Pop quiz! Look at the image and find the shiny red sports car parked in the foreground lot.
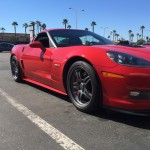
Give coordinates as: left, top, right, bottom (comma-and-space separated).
10, 29, 150, 113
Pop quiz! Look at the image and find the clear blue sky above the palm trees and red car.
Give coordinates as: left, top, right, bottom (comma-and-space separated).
0, 0, 150, 40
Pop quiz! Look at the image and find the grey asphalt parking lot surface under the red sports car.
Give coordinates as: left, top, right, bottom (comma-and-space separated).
0, 53, 150, 150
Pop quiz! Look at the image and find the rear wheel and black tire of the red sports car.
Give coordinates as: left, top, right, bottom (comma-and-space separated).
10, 55, 22, 82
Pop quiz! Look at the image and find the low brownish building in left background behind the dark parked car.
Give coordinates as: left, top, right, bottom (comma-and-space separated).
0, 32, 30, 44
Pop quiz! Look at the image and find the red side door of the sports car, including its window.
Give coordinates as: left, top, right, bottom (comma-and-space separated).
22, 33, 53, 85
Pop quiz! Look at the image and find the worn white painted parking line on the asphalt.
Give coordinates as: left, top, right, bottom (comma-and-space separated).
0, 88, 84, 150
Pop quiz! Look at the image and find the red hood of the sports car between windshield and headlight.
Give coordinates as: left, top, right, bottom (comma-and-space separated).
93, 45, 150, 61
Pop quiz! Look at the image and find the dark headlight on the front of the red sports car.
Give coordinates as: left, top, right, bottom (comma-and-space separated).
107, 51, 150, 67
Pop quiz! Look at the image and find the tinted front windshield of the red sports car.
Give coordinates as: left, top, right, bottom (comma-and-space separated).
49, 29, 114, 47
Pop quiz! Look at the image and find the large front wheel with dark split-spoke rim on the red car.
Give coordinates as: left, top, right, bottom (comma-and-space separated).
67, 61, 101, 112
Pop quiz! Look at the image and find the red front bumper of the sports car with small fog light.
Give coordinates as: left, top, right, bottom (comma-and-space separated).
97, 65, 150, 111
